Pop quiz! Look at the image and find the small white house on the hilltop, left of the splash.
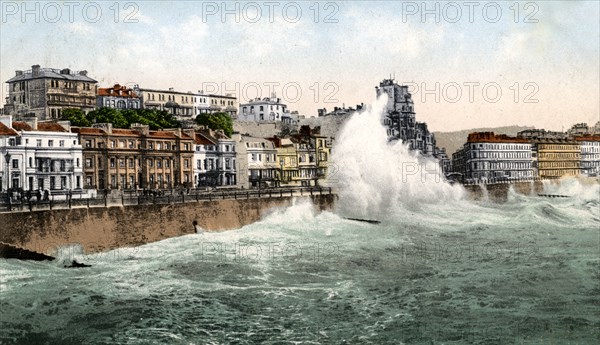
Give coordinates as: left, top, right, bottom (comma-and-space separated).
238, 97, 297, 122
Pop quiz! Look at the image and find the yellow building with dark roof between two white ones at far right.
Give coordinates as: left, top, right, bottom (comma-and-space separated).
534, 139, 581, 179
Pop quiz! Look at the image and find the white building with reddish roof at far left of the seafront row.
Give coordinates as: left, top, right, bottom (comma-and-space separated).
0, 116, 83, 194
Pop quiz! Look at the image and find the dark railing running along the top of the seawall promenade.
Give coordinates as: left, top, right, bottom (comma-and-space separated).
0, 187, 335, 213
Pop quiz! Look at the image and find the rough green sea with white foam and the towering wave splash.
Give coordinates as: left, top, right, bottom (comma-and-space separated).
0, 98, 600, 345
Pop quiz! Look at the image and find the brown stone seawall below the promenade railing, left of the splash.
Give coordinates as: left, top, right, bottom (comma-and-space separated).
0, 194, 337, 255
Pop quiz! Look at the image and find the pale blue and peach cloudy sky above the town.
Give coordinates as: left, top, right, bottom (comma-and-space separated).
0, 1, 600, 131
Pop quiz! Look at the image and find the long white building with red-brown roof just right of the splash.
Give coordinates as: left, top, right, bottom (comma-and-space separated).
452, 132, 535, 184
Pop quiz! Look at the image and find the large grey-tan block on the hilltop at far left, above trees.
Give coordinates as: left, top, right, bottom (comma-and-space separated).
4, 65, 97, 120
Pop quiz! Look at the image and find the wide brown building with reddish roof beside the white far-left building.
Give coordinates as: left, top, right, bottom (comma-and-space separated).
73, 124, 194, 190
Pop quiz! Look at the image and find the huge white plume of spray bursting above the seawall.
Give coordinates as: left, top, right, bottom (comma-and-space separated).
330, 94, 464, 218
